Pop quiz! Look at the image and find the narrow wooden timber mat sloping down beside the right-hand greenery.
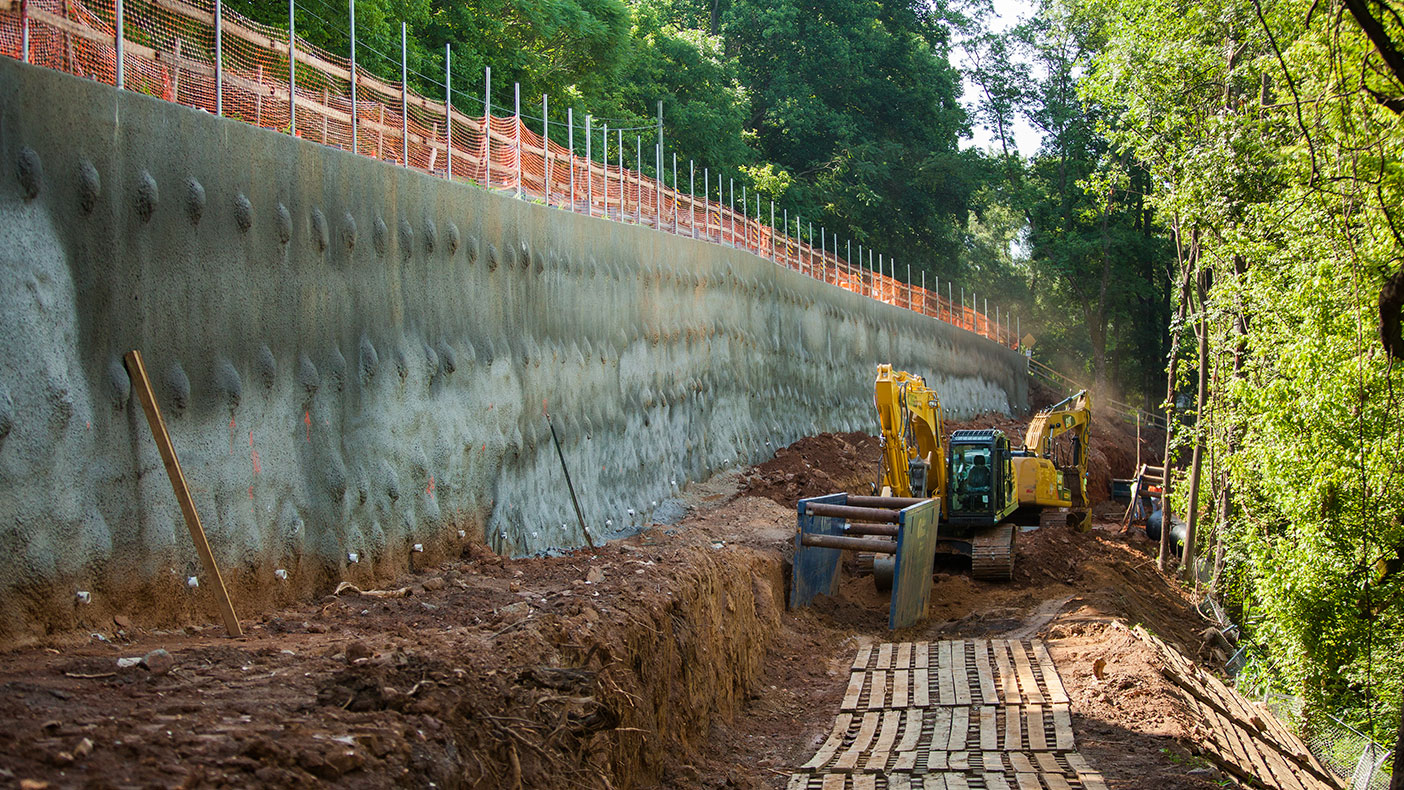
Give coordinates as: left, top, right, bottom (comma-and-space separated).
1132, 626, 1341, 790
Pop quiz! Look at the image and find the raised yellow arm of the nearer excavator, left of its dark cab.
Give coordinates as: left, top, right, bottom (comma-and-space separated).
873, 365, 946, 498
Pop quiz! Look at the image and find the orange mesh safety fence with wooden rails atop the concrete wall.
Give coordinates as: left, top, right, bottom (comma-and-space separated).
0, 0, 1019, 348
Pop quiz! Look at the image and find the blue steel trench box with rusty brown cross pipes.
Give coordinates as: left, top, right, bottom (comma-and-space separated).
789, 493, 941, 630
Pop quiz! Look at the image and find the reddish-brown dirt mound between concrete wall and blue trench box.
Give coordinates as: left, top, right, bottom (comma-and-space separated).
741, 432, 880, 508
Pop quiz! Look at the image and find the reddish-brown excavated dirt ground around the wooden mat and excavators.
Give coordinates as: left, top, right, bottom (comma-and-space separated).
0, 401, 1252, 790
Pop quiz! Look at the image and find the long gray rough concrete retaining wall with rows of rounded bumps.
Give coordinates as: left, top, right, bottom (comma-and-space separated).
0, 59, 1026, 637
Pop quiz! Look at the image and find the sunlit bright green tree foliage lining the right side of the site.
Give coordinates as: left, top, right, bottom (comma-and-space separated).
1071, 0, 1404, 742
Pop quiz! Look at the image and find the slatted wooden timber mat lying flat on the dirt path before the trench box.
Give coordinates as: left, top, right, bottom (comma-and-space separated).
789, 640, 1106, 790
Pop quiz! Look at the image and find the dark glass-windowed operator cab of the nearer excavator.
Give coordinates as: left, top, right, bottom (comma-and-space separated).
946, 429, 1018, 532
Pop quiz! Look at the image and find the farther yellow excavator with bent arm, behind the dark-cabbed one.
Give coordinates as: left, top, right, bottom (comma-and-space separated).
1014, 390, 1092, 532
